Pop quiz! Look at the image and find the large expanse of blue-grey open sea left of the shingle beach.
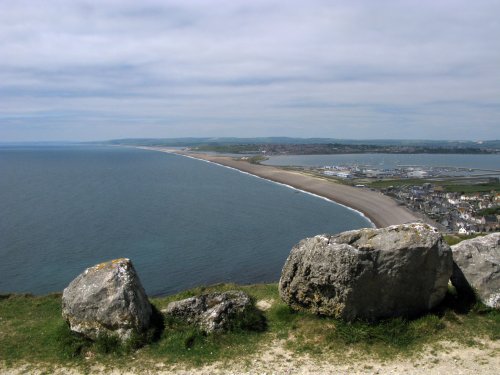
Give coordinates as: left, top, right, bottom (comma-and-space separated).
0, 146, 370, 295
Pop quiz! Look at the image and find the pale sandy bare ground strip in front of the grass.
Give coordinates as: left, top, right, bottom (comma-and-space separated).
0, 341, 500, 375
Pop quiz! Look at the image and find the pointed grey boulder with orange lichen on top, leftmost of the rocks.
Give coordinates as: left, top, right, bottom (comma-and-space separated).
62, 258, 152, 340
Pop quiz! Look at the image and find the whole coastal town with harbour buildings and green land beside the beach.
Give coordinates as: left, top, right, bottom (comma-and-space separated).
313, 166, 500, 235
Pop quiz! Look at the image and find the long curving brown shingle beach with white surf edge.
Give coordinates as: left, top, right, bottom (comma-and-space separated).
137, 147, 421, 228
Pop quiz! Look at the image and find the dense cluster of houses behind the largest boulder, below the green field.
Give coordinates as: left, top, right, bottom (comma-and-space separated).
382, 183, 500, 234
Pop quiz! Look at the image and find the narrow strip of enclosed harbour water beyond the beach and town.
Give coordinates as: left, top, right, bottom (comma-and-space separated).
264, 154, 500, 170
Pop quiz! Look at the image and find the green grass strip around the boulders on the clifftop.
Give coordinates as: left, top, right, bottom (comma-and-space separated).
0, 284, 500, 368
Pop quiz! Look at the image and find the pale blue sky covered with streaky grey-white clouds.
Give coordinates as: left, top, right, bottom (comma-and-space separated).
0, 0, 500, 142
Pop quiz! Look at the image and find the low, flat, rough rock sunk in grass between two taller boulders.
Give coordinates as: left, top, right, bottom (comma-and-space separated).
162, 291, 253, 333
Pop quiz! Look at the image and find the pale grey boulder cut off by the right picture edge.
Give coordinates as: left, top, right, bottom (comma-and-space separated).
451, 233, 500, 309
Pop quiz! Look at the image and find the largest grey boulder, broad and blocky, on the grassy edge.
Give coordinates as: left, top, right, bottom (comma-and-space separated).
279, 223, 452, 320
